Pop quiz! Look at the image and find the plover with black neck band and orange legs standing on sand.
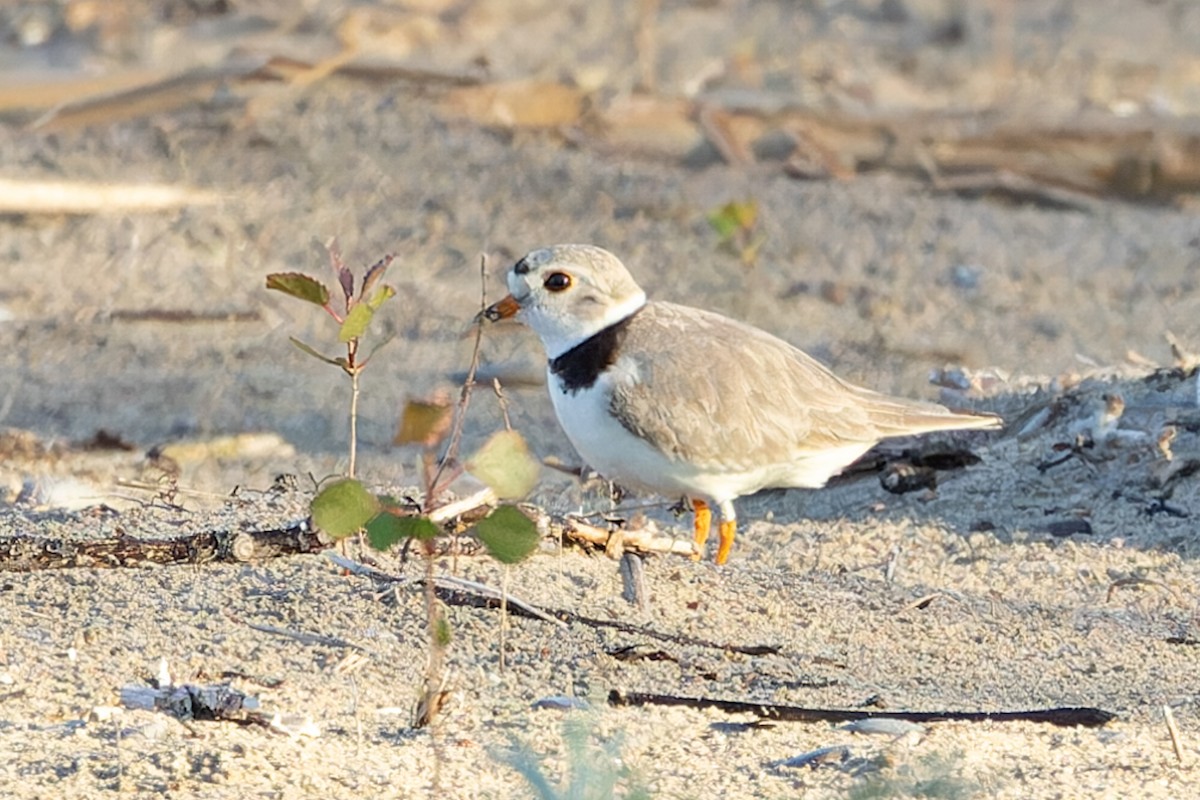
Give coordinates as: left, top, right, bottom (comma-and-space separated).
479, 245, 1002, 565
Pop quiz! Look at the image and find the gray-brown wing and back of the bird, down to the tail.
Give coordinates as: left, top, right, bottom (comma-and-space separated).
611, 302, 991, 469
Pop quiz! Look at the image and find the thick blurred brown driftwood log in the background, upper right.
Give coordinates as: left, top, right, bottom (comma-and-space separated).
588, 92, 1200, 203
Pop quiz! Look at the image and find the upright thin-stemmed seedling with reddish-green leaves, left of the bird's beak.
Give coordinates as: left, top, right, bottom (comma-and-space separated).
266, 242, 396, 477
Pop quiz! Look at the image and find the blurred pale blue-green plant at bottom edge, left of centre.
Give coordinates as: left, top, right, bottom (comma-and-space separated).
493, 716, 650, 800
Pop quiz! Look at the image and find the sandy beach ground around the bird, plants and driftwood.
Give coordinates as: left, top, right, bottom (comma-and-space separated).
0, 1, 1200, 799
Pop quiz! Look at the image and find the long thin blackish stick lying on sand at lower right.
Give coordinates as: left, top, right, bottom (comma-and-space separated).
608, 690, 1117, 728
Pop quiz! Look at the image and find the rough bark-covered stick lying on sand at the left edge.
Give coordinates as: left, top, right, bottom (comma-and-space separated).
0, 522, 331, 572
